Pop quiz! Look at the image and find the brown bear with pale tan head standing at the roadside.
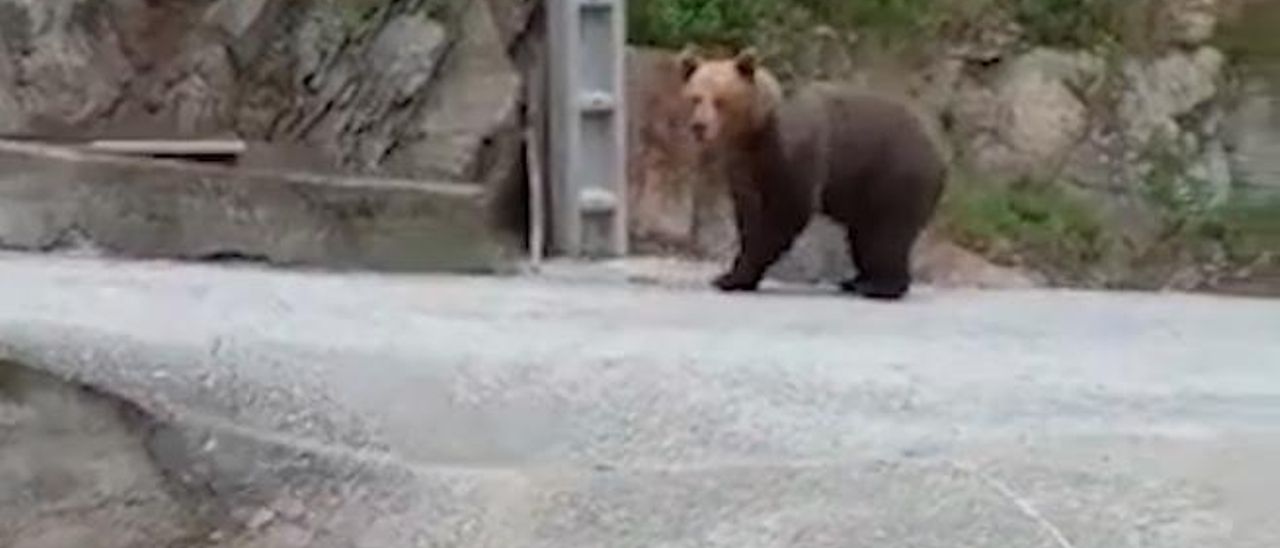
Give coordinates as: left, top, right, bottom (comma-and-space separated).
681, 49, 946, 300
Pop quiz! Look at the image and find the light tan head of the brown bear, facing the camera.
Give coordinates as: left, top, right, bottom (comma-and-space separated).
680, 47, 782, 145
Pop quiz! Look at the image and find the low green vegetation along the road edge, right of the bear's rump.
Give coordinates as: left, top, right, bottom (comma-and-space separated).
938, 154, 1280, 288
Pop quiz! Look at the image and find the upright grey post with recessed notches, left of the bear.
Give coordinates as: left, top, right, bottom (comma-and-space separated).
547, 0, 627, 256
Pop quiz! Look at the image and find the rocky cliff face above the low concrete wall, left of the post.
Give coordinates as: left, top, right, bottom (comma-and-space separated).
0, 0, 536, 186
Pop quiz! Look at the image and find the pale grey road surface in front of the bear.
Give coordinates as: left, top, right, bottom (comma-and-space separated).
0, 256, 1280, 548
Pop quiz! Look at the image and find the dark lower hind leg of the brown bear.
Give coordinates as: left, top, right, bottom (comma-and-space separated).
840, 222, 918, 300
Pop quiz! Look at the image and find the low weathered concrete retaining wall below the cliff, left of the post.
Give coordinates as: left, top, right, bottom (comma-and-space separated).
0, 143, 518, 271
